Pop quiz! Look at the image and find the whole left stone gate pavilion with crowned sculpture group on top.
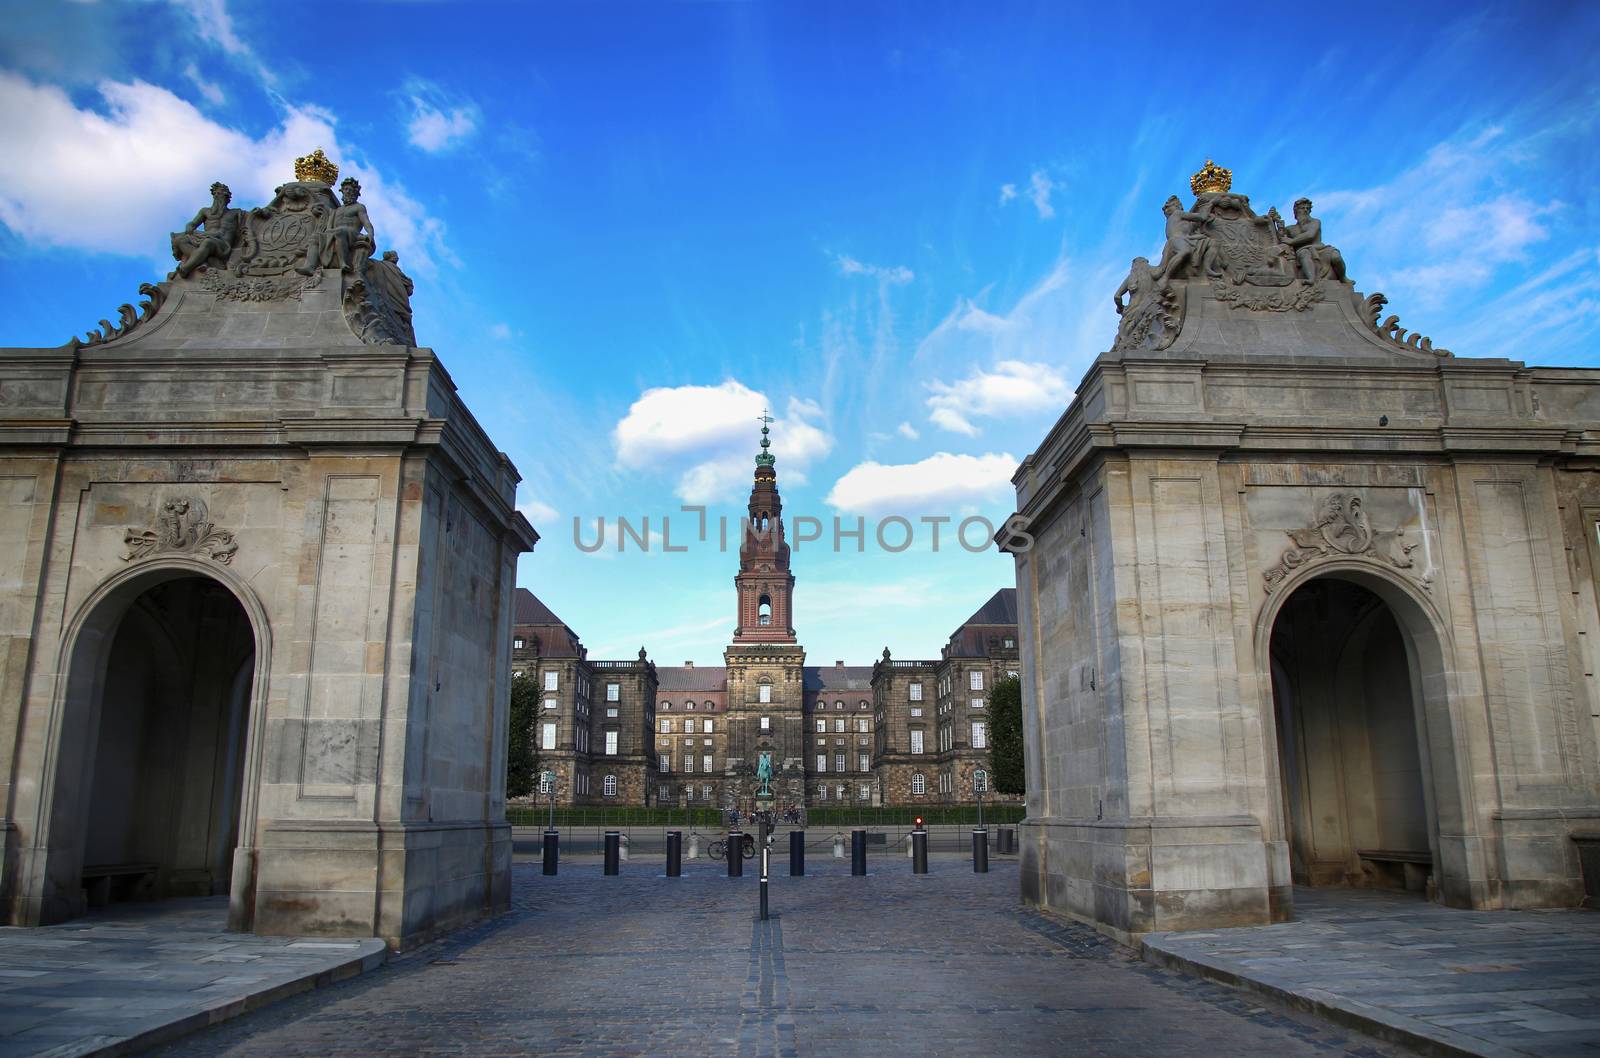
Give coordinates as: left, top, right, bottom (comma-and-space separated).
0, 150, 536, 946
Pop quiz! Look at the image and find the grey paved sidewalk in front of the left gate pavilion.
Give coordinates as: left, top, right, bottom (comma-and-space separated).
0, 896, 386, 1058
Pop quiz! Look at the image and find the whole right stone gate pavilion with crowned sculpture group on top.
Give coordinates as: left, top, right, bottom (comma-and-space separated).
1010, 162, 1600, 936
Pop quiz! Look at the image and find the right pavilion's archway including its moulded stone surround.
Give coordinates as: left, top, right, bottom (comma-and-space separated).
1258, 565, 1482, 906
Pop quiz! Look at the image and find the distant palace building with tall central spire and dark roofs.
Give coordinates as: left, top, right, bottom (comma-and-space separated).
512, 426, 1018, 808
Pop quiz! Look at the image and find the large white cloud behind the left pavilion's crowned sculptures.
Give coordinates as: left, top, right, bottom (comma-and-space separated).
0, 72, 454, 275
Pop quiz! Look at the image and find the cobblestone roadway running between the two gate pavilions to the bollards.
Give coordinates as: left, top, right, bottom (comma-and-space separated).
144, 856, 1403, 1058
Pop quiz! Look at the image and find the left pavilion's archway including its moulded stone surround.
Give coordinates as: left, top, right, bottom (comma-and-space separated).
34, 562, 266, 928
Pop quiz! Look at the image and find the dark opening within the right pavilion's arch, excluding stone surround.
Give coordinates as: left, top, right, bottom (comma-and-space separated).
1270, 576, 1437, 895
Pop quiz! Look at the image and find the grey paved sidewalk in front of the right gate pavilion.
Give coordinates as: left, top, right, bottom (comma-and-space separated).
1142, 888, 1600, 1058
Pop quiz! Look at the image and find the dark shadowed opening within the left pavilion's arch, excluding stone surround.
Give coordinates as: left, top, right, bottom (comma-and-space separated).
78, 576, 254, 906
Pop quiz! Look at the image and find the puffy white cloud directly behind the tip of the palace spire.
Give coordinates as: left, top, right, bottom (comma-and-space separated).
611, 379, 834, 503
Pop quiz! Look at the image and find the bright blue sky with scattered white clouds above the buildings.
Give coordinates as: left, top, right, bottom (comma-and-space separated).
0, 0, 1600, 663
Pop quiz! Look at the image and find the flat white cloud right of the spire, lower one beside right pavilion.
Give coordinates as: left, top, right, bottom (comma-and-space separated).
826, 451, 1018, 514
